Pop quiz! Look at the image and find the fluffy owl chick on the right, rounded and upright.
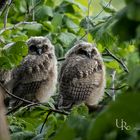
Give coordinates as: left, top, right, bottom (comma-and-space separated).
58, 42, 106, 109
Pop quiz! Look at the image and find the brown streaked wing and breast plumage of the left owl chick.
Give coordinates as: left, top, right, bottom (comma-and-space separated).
7, 55, 51, 94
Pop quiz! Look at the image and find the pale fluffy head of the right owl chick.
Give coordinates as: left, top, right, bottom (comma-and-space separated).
66, 42, 100, 59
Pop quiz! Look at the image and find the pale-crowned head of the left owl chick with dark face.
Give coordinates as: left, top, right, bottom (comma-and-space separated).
27, 36, 54, 55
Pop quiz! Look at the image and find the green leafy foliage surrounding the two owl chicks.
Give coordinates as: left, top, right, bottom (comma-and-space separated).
0, 0, 140, 140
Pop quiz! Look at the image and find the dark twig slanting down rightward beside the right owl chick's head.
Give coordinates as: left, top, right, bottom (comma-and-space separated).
102, 48, 129, 73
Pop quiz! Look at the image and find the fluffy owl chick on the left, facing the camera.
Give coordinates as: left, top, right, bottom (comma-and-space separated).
8, 37, 57, 102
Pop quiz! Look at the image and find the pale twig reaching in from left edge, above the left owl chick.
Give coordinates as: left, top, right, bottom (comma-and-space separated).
0, 21, 37, 34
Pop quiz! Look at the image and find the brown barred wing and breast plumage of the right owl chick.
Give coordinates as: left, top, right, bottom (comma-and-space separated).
59, 56, 102, 109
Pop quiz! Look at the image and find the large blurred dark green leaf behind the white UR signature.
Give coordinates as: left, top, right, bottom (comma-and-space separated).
87, 93, 140, 140
